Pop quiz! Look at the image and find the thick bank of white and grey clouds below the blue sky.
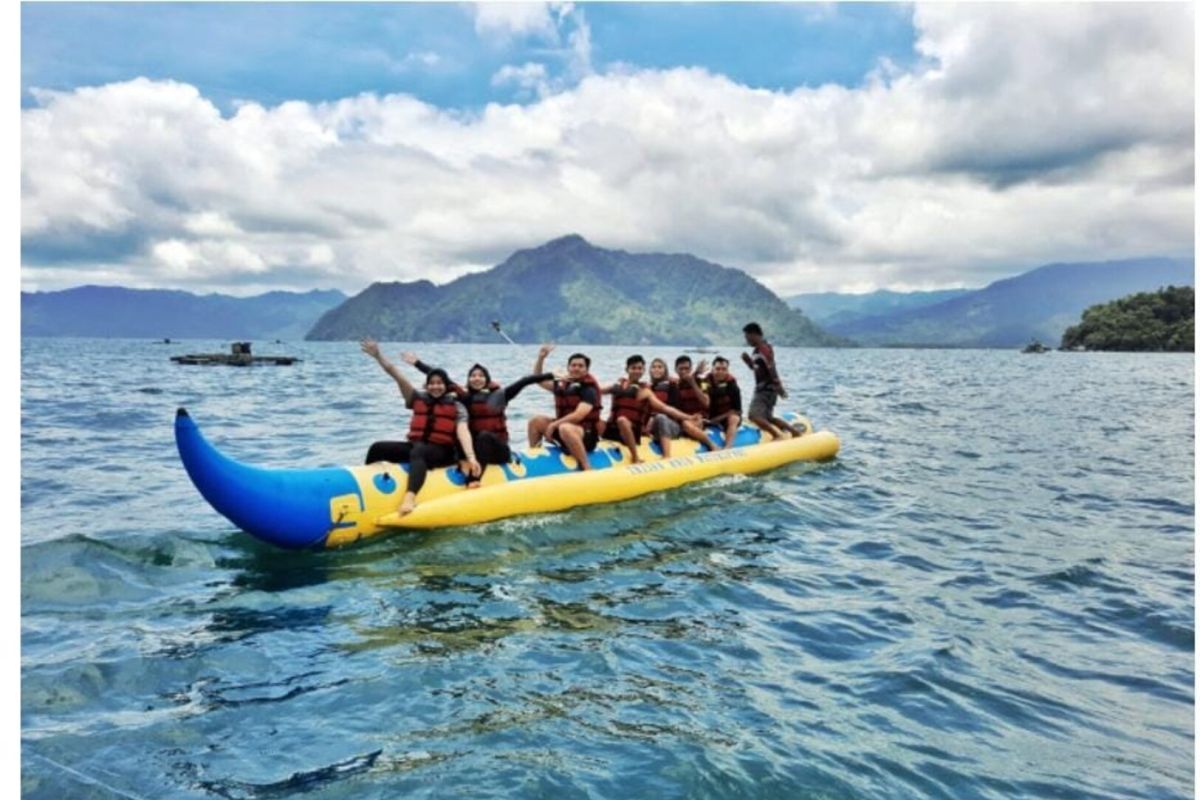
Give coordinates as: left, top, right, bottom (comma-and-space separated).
22, 4, 1194, 294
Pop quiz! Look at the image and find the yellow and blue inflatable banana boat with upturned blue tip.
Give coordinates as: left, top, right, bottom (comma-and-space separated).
175, 408, 840, 548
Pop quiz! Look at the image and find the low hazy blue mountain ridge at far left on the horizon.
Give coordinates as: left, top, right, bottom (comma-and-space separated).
20, 285, 346, 339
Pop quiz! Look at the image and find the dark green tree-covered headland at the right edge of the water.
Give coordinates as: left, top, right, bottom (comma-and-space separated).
1062, 285, 1195, 353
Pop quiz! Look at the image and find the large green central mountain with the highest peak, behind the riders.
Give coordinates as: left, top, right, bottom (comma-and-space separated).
307, 235, 846, 345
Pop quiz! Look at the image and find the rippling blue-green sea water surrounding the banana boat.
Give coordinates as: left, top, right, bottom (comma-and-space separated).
20, 339, 1195, 800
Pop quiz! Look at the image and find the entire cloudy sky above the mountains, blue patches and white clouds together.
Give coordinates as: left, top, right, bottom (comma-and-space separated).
20, 2, 1195, 295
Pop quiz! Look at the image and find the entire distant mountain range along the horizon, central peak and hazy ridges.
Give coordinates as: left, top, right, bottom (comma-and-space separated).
20, 245, 1195, 347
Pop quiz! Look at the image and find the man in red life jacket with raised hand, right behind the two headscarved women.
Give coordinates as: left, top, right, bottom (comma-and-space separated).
529, 344, 601, 470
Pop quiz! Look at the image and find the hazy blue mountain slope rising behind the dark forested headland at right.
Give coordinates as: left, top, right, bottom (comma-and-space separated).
829, 258, 1195, 347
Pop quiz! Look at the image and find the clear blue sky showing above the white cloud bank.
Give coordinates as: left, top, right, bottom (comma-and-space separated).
20, 2, 914, 110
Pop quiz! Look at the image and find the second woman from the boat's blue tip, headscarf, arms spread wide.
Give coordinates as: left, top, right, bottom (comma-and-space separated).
401, 353, 554, 489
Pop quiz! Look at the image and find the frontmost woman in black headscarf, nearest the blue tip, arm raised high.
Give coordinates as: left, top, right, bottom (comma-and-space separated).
361, 339, 481, 516
